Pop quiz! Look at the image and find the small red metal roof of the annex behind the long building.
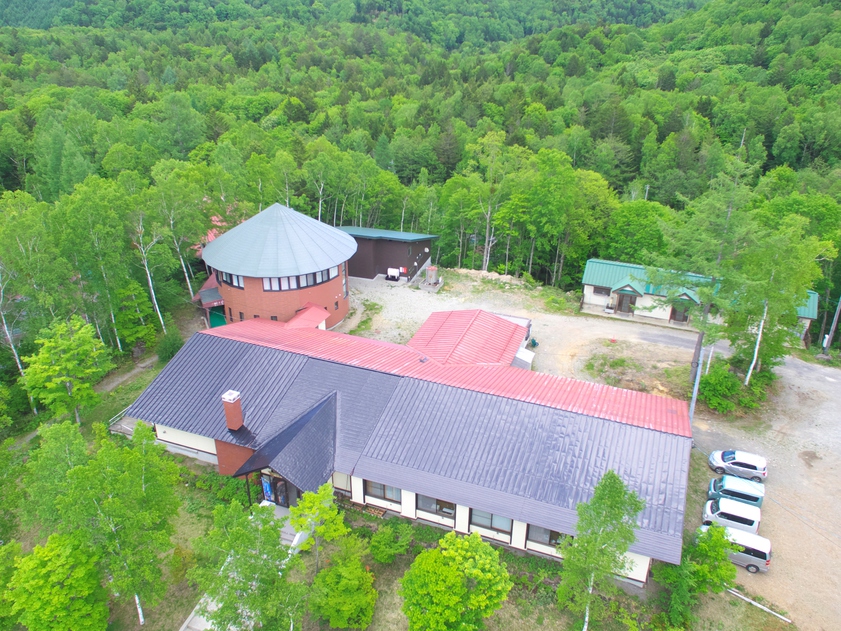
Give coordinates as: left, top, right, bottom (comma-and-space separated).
407, 309, 528, 366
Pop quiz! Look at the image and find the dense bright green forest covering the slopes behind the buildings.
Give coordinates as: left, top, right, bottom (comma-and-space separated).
0, 0, 841, 428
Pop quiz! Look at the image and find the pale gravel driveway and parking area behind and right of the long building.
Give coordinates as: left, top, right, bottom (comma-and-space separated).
337, 271, 841, 631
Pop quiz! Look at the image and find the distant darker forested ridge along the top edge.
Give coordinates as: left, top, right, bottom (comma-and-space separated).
0, 0, 705, 37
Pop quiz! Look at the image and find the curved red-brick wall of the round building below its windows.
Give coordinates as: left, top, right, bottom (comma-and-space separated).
219, 267, 348, 329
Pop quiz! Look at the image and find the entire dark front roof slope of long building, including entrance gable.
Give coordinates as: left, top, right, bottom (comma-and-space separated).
127, 334, 692, 563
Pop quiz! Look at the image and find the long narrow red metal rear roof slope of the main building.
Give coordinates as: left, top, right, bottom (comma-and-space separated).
202, 319, 692, 437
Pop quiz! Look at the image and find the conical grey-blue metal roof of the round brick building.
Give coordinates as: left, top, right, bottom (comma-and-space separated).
202, 204, 356, 278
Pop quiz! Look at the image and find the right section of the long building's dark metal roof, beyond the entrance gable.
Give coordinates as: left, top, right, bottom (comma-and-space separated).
353, 379, 692, 563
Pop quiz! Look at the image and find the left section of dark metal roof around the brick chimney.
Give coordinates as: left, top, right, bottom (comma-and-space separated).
126, 333, 400, 454
